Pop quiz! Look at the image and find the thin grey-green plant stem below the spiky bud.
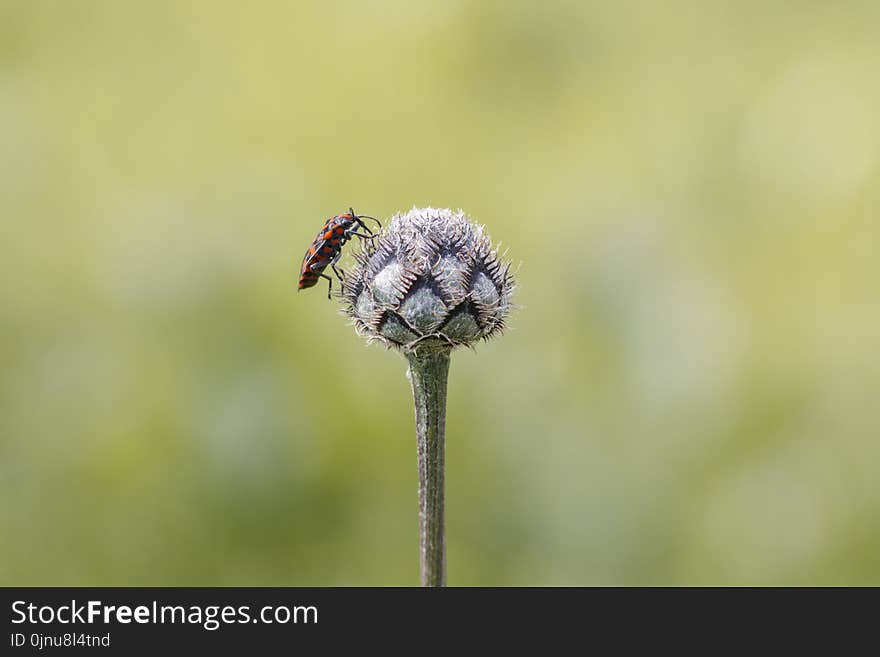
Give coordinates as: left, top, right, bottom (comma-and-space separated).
406, 348, 450, 586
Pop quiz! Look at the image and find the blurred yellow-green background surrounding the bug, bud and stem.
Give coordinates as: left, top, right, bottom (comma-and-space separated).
0, 0, 880, 585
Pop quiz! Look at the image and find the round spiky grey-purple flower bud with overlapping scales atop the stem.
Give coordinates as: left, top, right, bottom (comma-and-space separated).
342, 208, 513, 351
